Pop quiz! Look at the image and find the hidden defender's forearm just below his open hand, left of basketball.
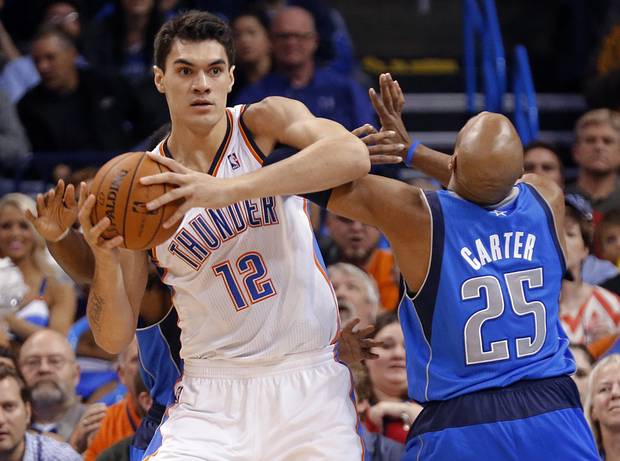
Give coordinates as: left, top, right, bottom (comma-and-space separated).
47, 229, 95, 284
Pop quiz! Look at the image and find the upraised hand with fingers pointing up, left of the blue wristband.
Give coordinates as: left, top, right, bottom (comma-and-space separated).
368, 74, 411, 159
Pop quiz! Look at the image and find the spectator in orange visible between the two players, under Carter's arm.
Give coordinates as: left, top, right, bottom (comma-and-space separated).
321, 213, 399, 310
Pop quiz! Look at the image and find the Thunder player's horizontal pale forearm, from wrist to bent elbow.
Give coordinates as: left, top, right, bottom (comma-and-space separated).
231, 136, 370, 201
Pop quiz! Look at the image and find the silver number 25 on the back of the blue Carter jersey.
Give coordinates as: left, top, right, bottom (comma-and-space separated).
461, 267, 547, 365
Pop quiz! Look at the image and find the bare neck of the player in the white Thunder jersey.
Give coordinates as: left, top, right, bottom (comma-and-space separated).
167, 115, 228, 173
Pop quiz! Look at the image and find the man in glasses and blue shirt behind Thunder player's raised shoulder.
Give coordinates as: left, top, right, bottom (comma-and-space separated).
237, 7, 374, 130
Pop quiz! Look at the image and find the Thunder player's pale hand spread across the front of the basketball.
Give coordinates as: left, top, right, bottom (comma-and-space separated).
140, 153, 230, 227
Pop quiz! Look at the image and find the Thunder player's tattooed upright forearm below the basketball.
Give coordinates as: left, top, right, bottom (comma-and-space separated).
86, 262, 137, 354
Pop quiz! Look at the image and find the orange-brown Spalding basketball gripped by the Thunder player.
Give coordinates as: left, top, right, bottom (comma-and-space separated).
91, 152, 181, 250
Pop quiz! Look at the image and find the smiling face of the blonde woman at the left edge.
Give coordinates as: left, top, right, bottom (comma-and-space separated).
0, 205, 34, 262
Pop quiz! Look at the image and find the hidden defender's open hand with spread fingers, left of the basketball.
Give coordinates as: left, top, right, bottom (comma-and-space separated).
26, 179, 78, 242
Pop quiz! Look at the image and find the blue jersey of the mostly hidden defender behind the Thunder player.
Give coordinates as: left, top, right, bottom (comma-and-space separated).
136, 307, 183, 407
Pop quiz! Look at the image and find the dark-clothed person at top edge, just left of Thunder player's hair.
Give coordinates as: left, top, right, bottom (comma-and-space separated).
84, 0, 162, 80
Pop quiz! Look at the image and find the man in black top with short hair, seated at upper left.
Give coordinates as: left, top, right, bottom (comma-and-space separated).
17, 28, 142, 151
